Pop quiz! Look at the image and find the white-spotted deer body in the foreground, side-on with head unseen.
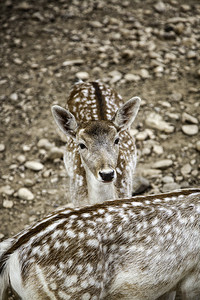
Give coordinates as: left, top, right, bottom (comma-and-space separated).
0, 188, 200, 300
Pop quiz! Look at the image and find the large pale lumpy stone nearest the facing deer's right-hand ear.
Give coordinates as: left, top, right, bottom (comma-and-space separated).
146, 113, 174, 133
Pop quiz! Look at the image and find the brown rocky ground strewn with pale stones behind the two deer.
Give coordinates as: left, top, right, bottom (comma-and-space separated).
0, 0, 200, 260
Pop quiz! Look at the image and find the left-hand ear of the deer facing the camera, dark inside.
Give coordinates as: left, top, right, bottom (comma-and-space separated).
51, 105, 78, 138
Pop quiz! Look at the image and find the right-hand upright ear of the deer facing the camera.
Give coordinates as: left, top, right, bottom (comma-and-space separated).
112, 97, 141, 131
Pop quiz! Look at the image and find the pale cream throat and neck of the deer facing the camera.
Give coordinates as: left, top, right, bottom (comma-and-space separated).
86, 170, 117, 205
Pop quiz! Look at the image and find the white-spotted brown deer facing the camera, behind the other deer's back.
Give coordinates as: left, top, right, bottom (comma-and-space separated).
52, 81, 140, 206
